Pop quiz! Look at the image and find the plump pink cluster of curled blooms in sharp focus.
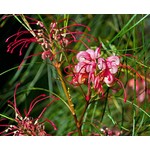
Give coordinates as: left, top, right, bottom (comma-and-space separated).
72, 48, 120, 99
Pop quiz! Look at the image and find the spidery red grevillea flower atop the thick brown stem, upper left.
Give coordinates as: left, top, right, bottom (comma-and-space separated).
6, 16, 94, 63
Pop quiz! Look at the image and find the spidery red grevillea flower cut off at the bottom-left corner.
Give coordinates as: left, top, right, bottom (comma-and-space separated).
0, 84, 58, 136
